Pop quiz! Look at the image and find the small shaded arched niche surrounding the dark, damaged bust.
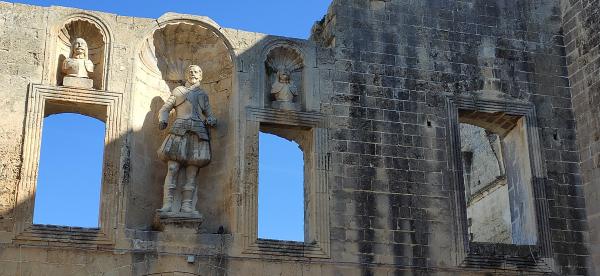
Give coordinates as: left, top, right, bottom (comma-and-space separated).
264, 45, 306, 110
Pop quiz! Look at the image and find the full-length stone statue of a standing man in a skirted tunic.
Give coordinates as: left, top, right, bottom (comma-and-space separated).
158, 65, 217, 216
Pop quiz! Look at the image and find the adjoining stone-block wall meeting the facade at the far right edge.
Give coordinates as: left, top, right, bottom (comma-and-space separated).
560, 1, 600, 273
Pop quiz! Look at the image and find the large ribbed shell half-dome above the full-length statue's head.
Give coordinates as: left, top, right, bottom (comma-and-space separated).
140, 22, 233, 85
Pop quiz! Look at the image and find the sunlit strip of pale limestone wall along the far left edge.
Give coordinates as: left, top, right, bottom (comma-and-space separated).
0, 3, 46, 233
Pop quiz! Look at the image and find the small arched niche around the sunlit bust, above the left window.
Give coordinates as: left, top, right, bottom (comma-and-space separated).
52, 15, 110, 90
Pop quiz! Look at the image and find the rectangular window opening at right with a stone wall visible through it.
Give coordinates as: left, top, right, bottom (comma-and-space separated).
459, 110, 537, 245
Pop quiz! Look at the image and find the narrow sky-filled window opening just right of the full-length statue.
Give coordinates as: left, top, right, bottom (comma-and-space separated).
258, 132, 304, 242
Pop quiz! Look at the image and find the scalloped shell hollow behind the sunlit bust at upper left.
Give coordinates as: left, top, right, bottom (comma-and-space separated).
56, 18, 106, 89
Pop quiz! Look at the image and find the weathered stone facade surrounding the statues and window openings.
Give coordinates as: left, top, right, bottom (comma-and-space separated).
0, 0, 600, 276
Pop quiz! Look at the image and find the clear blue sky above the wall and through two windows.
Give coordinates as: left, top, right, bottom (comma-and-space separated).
18, 0, 331, 241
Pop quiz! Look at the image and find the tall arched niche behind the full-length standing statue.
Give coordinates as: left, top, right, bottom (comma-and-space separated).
131, 18, 237, 231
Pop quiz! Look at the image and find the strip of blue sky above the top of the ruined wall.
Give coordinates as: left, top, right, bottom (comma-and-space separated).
9, 0, 331, 38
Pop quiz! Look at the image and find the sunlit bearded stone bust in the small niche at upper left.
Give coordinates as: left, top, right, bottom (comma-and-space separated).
62, 37, 94, 88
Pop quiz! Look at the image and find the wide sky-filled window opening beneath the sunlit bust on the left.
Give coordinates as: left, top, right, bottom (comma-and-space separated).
33, 113, 105, 228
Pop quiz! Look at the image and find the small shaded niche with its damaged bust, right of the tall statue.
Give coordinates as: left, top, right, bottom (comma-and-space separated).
265, 46, 305, 111
